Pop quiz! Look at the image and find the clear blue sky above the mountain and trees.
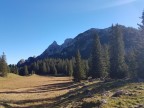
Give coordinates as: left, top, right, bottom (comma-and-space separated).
0, 0, 144, 64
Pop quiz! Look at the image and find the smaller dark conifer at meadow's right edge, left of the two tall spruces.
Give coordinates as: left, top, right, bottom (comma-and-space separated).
74, 50, 86, 82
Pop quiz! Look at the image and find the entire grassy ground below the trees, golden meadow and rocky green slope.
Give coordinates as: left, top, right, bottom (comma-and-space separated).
0, 74, 144, 108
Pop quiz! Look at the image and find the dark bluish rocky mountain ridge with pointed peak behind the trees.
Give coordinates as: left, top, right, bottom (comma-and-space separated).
18, 25, 144, 65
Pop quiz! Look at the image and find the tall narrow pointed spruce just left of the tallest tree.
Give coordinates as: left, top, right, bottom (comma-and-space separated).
90, 34, 104, 78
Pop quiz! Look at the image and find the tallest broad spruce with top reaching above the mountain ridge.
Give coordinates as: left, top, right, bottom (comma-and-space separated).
110, 24, 128, 79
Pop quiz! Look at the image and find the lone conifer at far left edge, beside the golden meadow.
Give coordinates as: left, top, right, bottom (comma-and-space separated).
0, 53, 8, 77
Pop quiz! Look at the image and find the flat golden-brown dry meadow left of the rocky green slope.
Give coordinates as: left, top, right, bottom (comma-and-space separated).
0, 74, 72, 108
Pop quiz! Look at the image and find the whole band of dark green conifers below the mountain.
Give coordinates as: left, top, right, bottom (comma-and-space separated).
0, 12, 144, 81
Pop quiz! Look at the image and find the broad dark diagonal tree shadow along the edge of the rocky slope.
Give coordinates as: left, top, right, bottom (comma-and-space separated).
49, 80, 136, 108
